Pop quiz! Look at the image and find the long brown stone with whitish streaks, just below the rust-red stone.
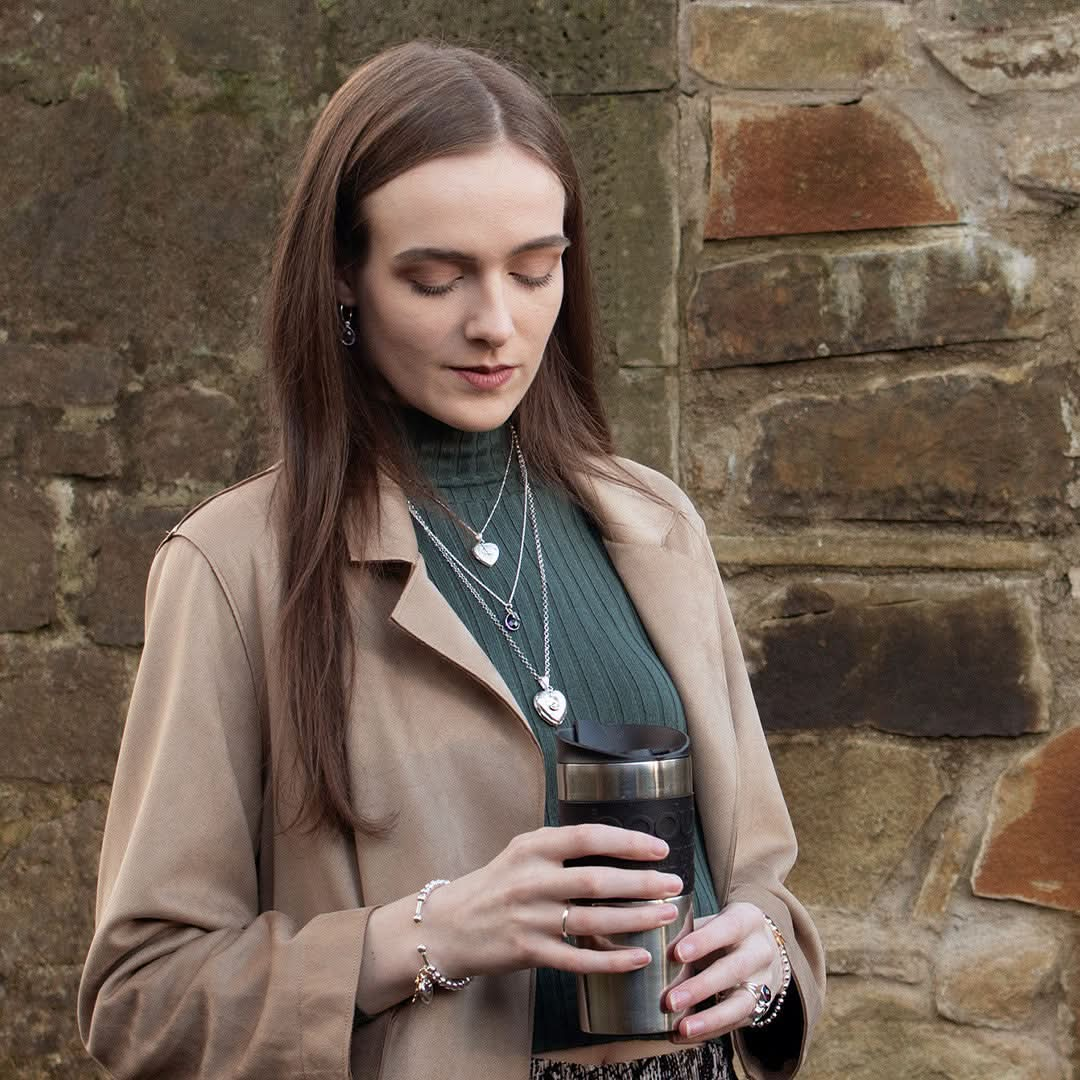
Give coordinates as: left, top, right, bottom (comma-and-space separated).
687, 233, 1040, 368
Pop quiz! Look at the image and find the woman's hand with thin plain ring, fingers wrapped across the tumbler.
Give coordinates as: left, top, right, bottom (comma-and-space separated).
414, 824, 683, 978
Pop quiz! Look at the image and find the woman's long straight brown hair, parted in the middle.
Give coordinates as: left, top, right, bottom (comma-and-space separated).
266, 41, 639, 831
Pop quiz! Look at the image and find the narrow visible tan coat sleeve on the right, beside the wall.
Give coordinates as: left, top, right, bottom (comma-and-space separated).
691, 511, 825, 1080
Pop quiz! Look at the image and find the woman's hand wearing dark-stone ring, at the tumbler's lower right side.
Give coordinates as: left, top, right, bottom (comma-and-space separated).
665, 903, 784, 1041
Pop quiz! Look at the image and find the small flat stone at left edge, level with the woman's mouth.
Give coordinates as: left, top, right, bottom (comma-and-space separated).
0, 345, 124, 408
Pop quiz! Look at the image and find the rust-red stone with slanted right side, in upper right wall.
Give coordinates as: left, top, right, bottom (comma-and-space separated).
705, 98, 959, 240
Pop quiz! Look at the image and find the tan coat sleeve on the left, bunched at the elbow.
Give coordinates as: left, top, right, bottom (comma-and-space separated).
78, 536, 370, 1080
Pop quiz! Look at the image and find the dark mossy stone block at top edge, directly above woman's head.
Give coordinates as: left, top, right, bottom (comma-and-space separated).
328, 0, 676, 94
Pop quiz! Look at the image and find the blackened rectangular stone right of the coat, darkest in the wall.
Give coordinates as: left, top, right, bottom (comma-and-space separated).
741, 580, 1051, 737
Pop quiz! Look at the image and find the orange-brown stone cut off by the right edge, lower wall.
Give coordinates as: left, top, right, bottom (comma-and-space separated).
972, 727, 1080, 912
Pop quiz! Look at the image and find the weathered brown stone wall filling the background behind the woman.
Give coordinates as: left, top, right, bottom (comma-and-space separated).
0, 0, 1080, 1080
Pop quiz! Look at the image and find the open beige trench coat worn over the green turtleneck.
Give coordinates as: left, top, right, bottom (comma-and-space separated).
78, 462, 824, 1080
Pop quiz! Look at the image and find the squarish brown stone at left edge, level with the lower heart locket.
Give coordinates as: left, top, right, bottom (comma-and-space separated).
0, 638, 129, 783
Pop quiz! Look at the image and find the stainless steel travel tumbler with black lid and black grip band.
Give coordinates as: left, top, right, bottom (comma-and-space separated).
556, 725, 694, 1036
